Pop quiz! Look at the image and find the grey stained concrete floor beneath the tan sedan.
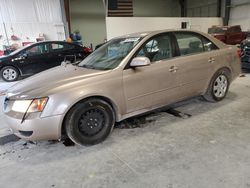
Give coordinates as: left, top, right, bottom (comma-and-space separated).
0, 74, 250, 188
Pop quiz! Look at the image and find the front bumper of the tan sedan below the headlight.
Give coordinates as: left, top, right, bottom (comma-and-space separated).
4, 114, 63, 140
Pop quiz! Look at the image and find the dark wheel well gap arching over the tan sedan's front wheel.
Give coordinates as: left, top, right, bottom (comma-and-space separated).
61, 96, 118, 135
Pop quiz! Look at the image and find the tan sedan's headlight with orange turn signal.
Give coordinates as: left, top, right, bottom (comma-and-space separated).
12, 97, 48, 113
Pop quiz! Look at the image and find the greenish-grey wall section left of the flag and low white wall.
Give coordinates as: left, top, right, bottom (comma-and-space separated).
70, 0, 106, 46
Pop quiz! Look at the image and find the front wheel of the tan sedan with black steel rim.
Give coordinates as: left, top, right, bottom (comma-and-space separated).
64, 99, 115, 145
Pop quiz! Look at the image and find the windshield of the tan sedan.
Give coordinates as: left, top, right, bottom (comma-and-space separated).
78, 37, 142, 70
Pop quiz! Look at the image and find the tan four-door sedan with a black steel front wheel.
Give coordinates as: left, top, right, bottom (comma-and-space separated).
1, 30, 241, 145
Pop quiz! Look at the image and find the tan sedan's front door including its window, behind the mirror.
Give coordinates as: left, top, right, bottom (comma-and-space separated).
123, 34, 182, 113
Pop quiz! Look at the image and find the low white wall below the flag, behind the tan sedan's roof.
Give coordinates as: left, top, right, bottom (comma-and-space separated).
106, 17, 222, 39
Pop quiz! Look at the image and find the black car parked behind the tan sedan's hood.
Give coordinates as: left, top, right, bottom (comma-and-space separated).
0, 41, 91, 82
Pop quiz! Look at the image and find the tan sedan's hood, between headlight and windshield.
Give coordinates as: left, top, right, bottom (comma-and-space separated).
7, 64, 111, 99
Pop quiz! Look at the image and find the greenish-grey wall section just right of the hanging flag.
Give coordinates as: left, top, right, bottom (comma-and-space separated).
133, 0, 180, 17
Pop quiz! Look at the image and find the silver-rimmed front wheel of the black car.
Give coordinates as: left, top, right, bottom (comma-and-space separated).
1, 66, 20, 82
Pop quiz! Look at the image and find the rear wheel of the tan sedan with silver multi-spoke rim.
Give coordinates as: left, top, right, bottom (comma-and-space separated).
203, 69, 230, 102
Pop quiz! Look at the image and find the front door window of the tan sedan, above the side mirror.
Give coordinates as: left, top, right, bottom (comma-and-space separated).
136, 35, 172, 62
